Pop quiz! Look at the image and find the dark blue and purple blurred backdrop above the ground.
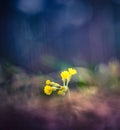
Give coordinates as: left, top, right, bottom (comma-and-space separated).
0, 0, 120, 72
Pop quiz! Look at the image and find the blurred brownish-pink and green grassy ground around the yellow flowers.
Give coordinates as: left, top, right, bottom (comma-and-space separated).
0, 61, 120, 130
